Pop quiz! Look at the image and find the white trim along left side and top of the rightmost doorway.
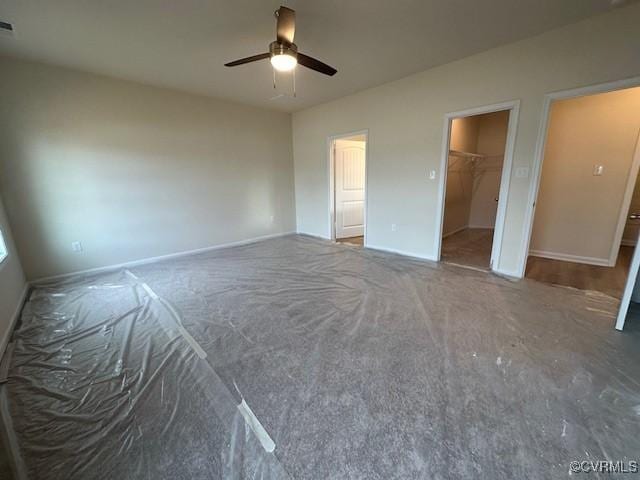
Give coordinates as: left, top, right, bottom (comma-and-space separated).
518, 77, 640, 278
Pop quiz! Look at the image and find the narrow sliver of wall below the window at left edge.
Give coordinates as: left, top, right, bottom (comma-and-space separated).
0, 193, 26, 358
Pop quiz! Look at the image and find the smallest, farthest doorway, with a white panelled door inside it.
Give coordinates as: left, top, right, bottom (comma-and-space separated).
329, 131, 368, 247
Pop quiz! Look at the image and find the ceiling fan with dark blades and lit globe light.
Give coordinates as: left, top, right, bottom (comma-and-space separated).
224, 7, 337, 76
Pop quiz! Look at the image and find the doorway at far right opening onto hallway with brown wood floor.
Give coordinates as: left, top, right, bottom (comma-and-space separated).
525, 87, 640, 299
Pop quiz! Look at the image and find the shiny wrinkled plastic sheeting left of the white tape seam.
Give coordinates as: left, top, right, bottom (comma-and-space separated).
7, 271, 288, 479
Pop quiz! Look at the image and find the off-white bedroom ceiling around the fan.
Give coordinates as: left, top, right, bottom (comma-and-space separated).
0, 0, 632, 111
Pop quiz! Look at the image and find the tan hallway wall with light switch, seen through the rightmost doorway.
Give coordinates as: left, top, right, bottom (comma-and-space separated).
531, 88, 640, 263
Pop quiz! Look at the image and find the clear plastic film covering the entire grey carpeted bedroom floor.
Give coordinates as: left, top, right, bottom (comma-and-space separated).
0, 235, 640, 480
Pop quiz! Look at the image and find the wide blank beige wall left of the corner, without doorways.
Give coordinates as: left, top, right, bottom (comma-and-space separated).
0, 58, 295, 279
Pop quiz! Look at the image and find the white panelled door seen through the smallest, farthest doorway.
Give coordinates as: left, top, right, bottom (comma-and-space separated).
334, 140, 366, 238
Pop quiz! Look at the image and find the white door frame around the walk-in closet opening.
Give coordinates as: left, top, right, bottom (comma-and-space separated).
434, 100, 520, 273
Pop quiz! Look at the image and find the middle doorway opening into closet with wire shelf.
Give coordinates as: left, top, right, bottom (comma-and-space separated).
437, 102, 518, 270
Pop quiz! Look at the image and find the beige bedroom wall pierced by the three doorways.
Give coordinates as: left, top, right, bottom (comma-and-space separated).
293, 4, 640, 275
